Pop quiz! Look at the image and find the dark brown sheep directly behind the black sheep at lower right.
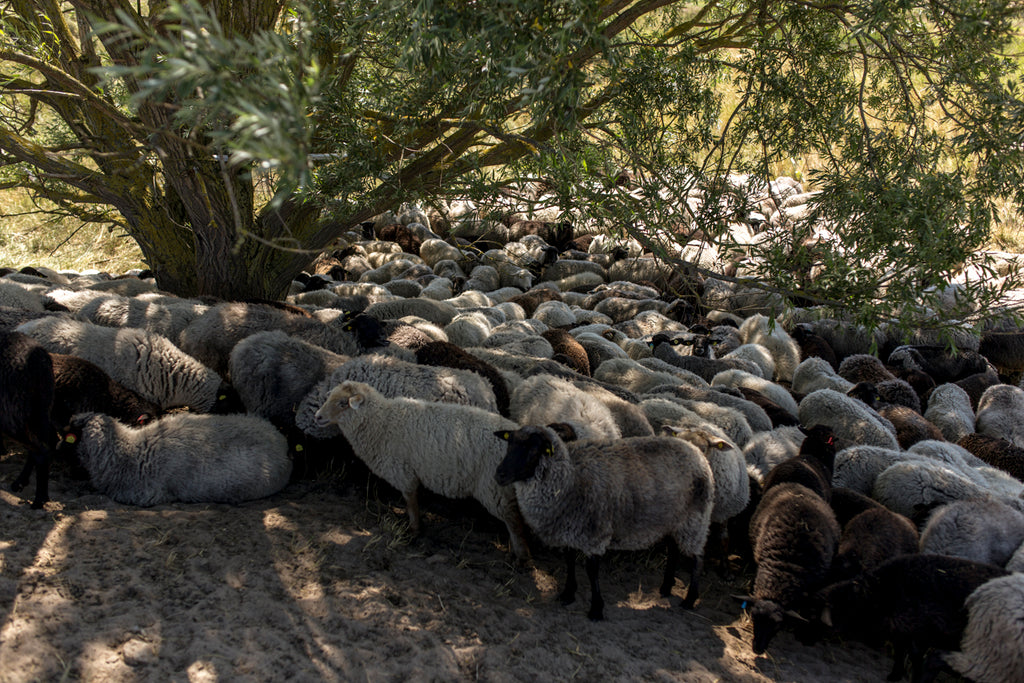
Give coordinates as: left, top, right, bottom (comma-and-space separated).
831, 507, 920, 582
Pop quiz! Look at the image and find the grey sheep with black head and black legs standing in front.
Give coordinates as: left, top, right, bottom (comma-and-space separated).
495, 425, 715, 621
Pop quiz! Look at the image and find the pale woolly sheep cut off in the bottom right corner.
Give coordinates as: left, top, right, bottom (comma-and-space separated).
945, 573, 1024, 683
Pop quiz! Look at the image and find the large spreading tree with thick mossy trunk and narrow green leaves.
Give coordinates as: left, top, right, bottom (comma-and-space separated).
0, 0, 1024, 331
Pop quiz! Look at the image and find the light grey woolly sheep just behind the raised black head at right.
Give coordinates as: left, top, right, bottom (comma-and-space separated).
797, 389, 899, 450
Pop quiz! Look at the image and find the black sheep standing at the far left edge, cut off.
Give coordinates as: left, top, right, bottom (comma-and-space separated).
0, 332, 57, 510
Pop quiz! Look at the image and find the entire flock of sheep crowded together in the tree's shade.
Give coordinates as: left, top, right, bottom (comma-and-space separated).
0, 178, 1024, 682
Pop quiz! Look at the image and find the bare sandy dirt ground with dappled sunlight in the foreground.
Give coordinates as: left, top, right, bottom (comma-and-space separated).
0, 452, 951, 683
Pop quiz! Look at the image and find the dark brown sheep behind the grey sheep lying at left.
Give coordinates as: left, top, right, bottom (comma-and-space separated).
50, 353, 160, 427
